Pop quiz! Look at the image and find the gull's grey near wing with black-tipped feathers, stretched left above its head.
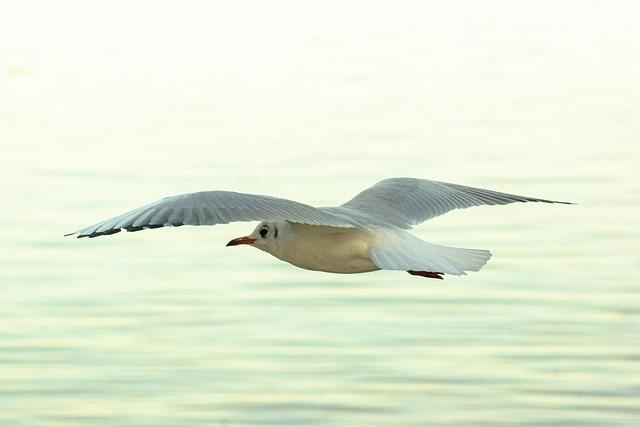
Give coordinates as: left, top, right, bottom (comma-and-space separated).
67, 191, 353, 238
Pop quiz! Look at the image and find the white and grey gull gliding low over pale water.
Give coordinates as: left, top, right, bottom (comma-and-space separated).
66, 178, 571, 279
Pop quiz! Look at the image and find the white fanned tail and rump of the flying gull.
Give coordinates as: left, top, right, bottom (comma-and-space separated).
369, 230, 491, 275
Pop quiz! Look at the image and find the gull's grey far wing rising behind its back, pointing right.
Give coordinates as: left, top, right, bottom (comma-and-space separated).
339, 178, 571, 229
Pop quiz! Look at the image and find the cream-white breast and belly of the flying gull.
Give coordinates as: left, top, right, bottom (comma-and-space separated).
273, 223, 379, 273
